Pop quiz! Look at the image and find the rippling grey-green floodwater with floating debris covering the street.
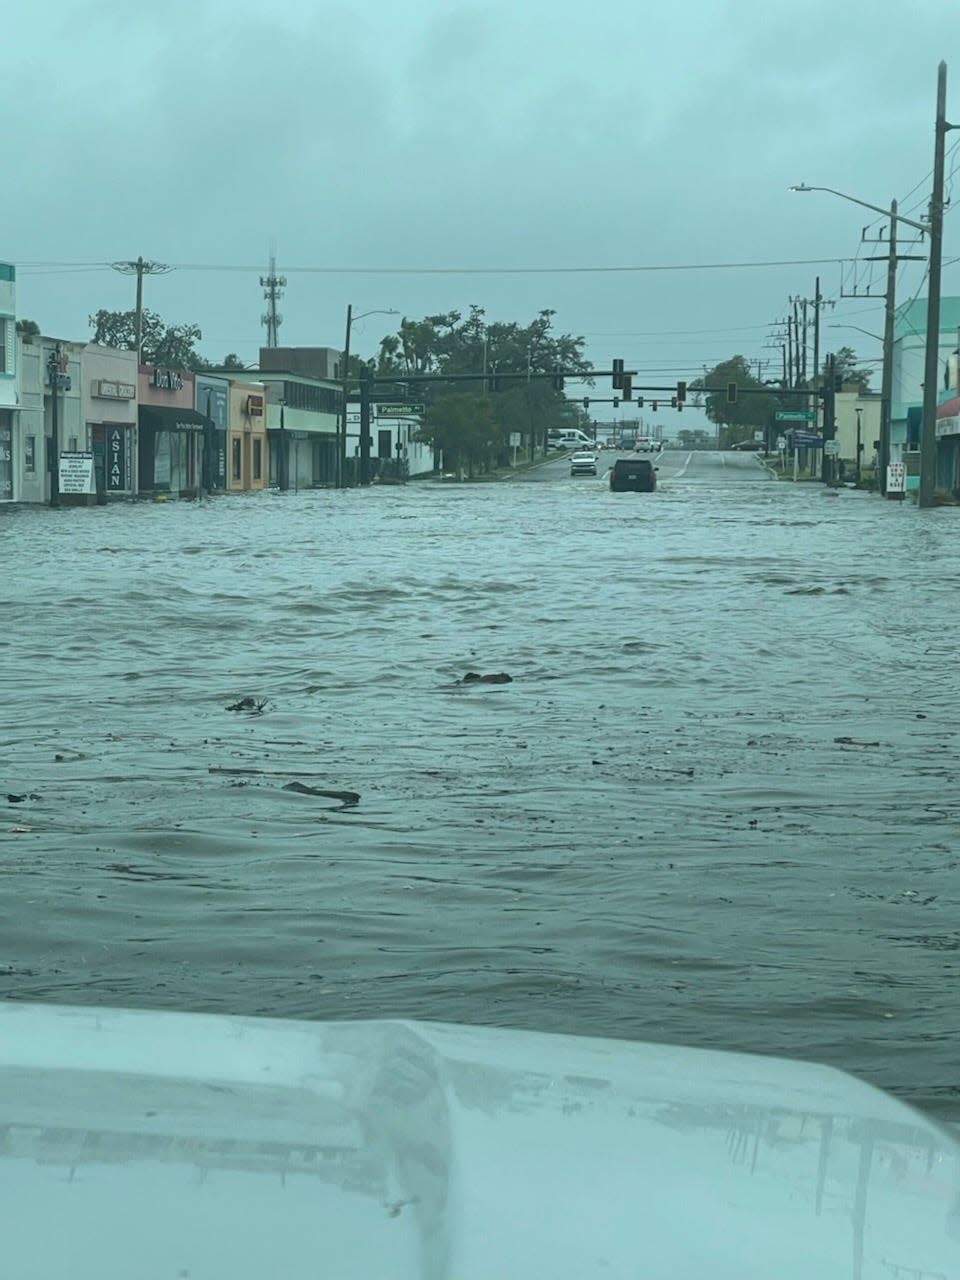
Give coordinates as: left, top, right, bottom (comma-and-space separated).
0, 453, 960, 1120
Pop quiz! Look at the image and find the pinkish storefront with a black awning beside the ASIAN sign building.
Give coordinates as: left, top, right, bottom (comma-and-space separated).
137, 365, 209, 498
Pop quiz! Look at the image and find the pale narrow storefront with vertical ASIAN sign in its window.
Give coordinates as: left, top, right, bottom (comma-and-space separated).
81, 342, 137, 502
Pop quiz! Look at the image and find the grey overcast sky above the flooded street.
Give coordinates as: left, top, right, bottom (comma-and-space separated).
7, 0, 960, 421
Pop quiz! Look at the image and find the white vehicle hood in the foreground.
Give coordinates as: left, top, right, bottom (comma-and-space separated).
0, 1004, 960, 1280
